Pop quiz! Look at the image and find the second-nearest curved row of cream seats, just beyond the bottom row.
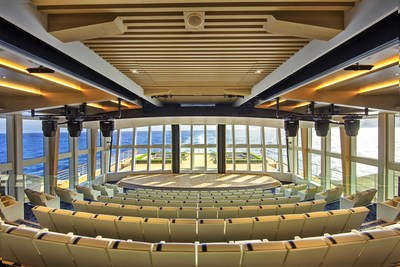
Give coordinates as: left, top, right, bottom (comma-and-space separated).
32, 206, 369, 242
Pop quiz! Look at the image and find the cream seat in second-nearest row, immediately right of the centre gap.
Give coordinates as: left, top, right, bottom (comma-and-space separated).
197, 219, 225, 242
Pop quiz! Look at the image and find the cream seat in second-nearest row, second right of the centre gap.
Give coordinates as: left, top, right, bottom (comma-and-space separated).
225, 218, 253, 241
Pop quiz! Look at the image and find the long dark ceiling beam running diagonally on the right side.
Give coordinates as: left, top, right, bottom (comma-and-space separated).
247, 11, 400, 103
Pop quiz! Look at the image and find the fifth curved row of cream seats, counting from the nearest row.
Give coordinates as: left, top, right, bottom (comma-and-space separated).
115, 193, 284, 201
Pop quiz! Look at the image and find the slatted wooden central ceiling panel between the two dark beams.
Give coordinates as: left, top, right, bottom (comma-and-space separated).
31, 0, 358, 103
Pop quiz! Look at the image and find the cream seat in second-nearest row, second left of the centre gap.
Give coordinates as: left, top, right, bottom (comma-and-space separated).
141, 218, 170, 242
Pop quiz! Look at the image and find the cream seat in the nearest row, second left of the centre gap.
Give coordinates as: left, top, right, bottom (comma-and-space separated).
107, 240, 153, 267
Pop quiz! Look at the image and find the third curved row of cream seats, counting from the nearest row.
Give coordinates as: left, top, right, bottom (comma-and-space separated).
72, 200, 326, 219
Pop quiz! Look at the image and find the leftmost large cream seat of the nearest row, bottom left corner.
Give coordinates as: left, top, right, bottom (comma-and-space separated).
1, 225, 46, 267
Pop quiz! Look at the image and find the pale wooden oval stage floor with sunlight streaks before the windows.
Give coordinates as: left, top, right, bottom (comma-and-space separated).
119, 173, 280, 190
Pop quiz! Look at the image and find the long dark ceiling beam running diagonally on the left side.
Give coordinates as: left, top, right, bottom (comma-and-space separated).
0, 18, 153, 105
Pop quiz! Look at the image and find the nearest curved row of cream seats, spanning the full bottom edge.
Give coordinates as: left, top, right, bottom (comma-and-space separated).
1, 224, 400, 267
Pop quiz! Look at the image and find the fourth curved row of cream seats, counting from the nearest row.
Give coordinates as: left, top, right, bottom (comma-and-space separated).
97, 196, 300, 208
